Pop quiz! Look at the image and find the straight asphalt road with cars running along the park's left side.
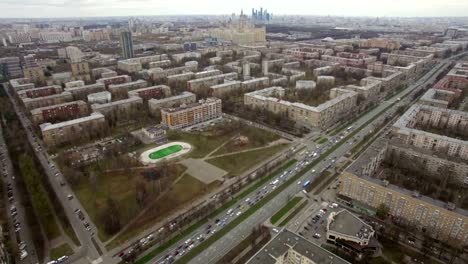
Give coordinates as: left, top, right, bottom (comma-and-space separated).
5, 86, 112, 264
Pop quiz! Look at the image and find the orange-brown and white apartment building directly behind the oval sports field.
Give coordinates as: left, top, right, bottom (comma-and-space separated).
161, 97, 222, 129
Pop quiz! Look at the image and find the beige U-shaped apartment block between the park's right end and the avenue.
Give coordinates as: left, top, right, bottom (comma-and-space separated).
244, 87, 358, 129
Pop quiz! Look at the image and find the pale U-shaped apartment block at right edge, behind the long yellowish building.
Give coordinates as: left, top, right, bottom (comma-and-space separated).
392, 104, 468, 161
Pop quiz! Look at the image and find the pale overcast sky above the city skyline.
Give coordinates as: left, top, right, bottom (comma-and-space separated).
0, 0, 468, 17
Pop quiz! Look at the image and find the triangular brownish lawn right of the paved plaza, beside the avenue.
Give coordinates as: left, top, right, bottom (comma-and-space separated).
207, 144, 289, 177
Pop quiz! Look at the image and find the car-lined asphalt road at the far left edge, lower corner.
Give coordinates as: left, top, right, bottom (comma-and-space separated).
0, 126, 38, 264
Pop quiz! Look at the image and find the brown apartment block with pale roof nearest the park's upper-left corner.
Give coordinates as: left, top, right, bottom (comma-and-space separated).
40, 113, 107, 146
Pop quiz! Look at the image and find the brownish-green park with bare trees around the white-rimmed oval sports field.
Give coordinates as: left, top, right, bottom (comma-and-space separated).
64, 122, 289, 248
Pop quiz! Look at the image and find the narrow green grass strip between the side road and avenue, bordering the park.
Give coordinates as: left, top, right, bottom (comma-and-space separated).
135, 159, 296, 264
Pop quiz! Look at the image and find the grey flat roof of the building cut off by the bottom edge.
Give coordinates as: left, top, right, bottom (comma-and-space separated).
247, 229, 350, 264
